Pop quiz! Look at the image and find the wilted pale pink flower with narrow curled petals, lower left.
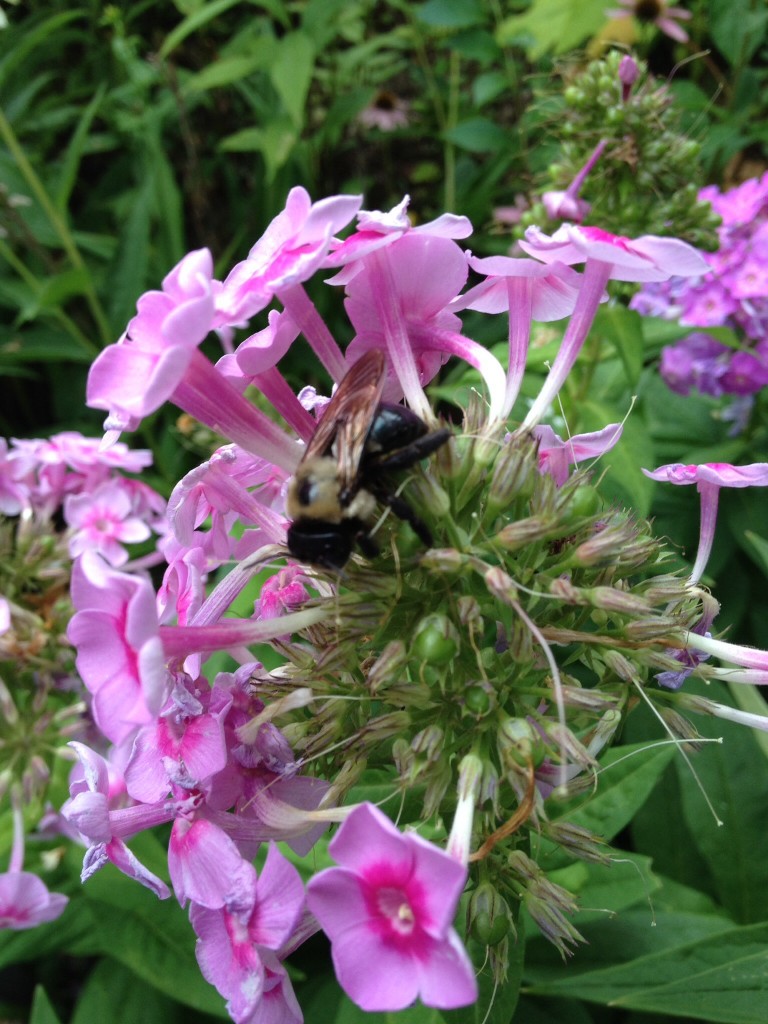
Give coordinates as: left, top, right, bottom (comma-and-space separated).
61, 742, 174, 899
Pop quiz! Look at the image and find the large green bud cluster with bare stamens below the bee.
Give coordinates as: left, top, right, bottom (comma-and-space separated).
274, 415, 705, 958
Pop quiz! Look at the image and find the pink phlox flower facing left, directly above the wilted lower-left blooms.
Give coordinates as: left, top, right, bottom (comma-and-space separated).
67, 552, 168, 743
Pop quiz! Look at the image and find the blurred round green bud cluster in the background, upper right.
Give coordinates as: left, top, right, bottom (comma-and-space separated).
520, 50, 720, 251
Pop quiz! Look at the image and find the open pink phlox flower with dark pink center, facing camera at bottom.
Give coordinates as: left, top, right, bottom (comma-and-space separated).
307, 804, 477, 1012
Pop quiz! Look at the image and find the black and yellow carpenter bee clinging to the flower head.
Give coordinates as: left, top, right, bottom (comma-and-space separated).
286, 349, 451, 569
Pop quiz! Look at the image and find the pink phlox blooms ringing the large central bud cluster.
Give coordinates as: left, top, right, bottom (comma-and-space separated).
51, 188, 706, 1024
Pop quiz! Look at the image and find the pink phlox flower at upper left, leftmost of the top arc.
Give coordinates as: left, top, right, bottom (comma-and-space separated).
87, 249, 220, 420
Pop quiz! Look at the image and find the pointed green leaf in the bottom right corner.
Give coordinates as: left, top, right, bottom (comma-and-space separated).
530, 924, 768, 1024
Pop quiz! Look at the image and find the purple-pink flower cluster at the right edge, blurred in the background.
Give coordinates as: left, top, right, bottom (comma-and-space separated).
631, 173, 768, 396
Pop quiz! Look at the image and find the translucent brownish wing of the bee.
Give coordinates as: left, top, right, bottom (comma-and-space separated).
302, 348, 384, 487
